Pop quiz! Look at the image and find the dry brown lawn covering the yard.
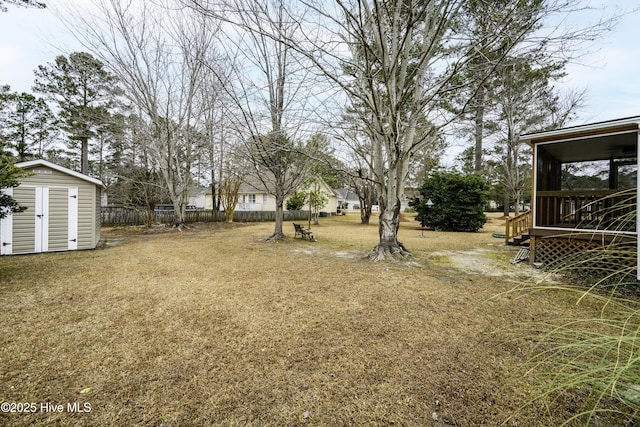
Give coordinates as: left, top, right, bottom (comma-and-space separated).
0, 215, 608, 426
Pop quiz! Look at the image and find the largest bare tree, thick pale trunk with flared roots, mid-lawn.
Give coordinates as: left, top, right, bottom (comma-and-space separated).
273, 0, 620, 260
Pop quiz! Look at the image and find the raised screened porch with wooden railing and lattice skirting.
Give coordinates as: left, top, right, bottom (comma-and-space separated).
521, 116, 640, 278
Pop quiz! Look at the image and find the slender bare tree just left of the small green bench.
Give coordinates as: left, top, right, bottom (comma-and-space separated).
187, 0, 320, 240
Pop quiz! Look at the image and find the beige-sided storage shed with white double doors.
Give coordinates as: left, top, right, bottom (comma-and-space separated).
0, 160, 104, 255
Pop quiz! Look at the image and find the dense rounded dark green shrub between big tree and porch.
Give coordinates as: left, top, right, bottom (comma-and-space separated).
409, 172, 489, 232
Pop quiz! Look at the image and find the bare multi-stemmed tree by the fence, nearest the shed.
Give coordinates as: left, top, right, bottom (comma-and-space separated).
60, 0, 222, 224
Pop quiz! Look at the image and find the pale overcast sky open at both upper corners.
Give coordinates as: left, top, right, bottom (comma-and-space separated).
0, 0, 640, 124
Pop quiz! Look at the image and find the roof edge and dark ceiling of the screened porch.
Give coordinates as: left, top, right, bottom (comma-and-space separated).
520, 116, 640, 163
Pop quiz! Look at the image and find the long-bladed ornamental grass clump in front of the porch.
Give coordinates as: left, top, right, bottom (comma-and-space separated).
527, 189, 640, 425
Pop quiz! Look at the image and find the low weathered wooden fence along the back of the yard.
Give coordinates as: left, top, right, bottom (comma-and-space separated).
101, 206, 309, 226
